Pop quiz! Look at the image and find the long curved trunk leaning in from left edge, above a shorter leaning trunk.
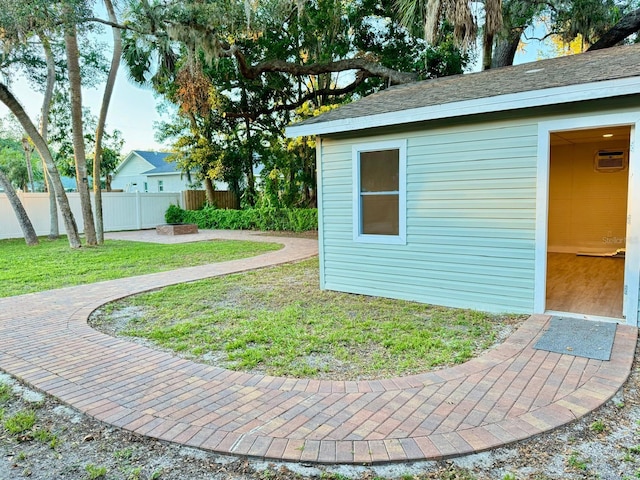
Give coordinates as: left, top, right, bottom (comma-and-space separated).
0, 82, 81, 248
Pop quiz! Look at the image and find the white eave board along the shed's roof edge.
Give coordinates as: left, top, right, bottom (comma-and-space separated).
285, 77, 640, 137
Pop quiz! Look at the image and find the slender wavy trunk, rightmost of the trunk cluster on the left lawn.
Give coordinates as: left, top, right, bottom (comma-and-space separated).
93, 0, 122, 245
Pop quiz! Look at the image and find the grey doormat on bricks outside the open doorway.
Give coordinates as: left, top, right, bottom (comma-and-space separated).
533, 317, 616, 361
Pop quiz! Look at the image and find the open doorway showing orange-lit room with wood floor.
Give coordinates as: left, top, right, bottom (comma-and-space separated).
546, 126, 631, 319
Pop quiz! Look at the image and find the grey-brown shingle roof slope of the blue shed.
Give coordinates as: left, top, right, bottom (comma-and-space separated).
292, 44, 640, 135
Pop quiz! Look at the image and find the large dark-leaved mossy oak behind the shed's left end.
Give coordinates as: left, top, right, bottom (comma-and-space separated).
132, 0, 467, 205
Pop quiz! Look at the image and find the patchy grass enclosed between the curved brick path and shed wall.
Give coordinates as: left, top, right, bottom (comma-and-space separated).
91, 259, 522, 380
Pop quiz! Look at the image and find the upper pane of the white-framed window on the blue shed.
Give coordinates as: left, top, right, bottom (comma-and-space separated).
360, 150, 400, 192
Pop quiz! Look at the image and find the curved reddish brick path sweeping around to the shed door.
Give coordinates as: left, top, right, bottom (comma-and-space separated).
0, 232, 637, 464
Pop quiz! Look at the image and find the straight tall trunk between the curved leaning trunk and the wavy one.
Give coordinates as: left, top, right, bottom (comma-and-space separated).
64, 23, 100, 245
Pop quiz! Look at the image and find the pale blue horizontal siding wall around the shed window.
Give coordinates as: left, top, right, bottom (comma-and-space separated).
320, 121, 537, 312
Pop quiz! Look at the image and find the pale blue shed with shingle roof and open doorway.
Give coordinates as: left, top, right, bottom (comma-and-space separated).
287, 44, 640, 325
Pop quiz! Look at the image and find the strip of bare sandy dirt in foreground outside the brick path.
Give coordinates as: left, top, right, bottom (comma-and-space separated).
0, 344, 640, 480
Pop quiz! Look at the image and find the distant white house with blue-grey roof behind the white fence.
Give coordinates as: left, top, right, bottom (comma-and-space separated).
111, 150, 190, 192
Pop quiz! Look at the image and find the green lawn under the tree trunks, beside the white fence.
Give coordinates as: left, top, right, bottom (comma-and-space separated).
0, 238, 281, 297
